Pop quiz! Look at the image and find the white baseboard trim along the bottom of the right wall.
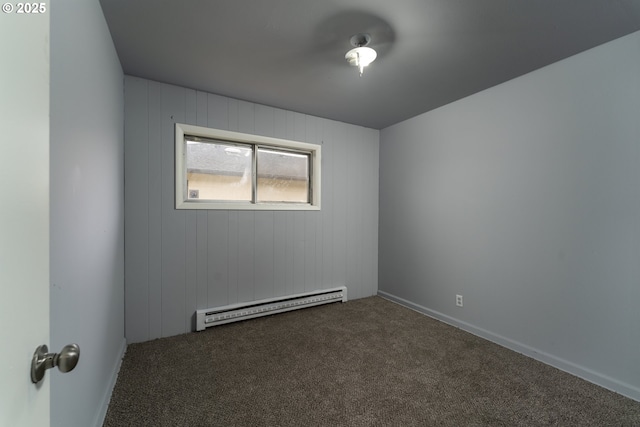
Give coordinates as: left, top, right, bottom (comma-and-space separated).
378, 290, 640, 402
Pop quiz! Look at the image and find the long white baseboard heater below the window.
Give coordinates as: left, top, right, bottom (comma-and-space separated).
196, 286, 347, 331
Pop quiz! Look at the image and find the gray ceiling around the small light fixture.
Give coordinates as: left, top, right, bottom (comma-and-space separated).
100, 0, 640, 129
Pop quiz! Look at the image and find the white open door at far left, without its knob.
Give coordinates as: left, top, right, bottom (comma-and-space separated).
0, 2, 50, 427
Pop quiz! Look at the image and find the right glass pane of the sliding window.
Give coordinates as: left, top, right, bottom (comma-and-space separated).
257, 148, 309, 203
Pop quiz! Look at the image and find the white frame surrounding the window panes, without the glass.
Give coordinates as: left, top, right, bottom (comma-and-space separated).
175, 123, 321, 211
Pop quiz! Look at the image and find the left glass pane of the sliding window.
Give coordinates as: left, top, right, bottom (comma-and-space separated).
186, 140, 253, 201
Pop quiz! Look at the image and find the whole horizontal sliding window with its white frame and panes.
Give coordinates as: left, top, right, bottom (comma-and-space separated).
176, 123, 320, 210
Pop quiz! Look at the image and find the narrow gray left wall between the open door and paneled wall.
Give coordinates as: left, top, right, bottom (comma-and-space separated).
50, 0, 125, 427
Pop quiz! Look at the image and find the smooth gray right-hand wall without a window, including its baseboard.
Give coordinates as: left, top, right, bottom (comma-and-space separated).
379, 33, 640, 399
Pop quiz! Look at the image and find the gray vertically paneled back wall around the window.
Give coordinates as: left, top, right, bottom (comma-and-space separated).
125, 76, 379, 342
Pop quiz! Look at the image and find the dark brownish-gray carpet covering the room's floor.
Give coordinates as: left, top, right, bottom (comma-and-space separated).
104, 297, 640, 427
